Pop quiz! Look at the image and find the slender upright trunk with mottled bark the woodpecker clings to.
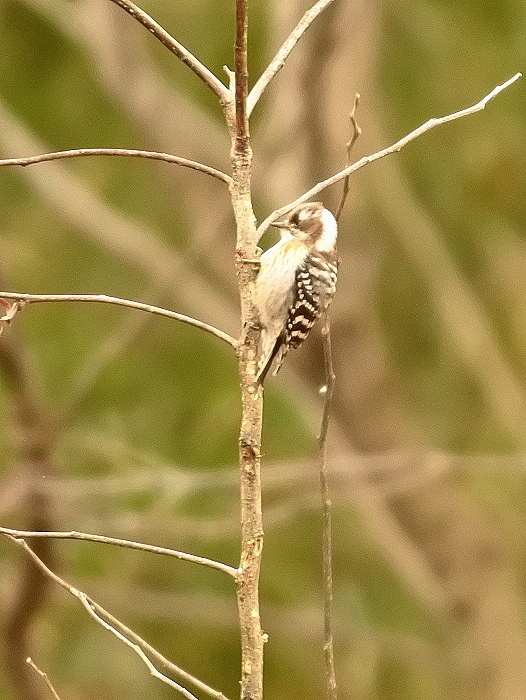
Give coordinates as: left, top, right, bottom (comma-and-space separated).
227, 0, 264, 700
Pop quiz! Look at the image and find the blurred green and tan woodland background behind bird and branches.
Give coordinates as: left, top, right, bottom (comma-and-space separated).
0, 0, 526, 700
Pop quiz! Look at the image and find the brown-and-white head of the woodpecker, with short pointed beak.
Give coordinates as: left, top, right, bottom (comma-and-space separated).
272, 202, 338, 251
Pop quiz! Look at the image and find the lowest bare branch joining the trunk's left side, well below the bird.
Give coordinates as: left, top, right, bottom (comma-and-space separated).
0, 527, 238, 578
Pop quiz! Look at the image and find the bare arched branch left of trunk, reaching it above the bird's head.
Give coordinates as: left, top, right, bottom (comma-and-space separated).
0, 148, 232, 185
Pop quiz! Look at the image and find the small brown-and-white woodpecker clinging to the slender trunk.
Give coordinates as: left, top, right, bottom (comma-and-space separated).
254, 202, 338, 383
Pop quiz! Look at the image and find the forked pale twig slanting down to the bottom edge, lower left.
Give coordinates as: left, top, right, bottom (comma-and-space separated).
6, 535, 231, 700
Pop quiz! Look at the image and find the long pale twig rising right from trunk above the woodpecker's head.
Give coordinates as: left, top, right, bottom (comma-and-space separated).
258, 73, 522, 237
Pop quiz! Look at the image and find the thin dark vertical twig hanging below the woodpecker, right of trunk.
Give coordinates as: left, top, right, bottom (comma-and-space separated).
318, 314, 338, 700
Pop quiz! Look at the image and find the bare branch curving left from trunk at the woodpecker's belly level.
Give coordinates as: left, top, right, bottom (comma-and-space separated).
0, 292, 237, 348
